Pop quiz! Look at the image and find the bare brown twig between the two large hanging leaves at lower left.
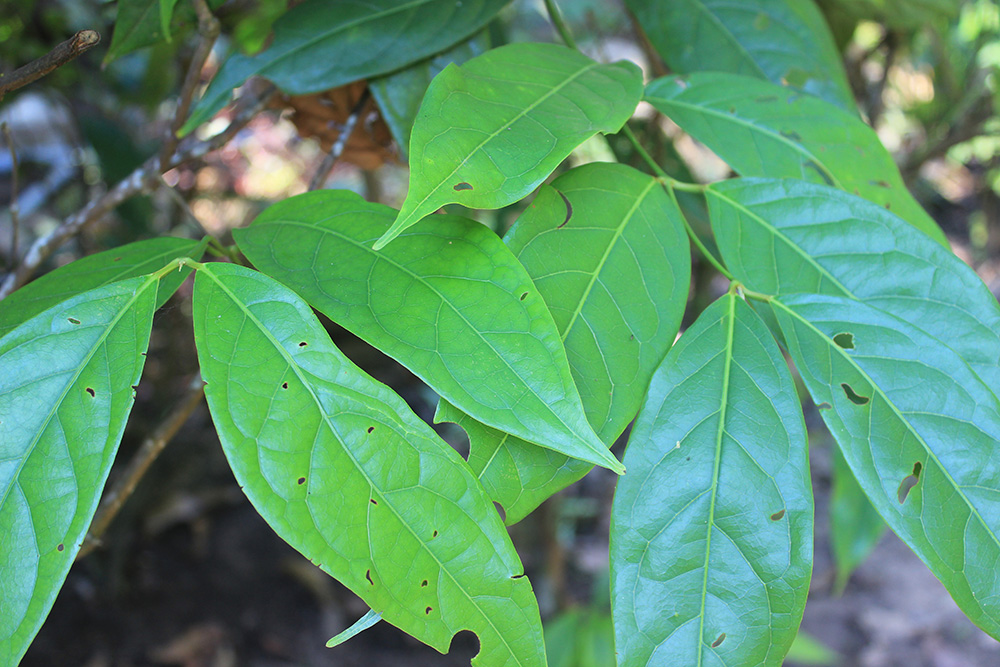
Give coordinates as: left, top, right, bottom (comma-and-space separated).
76, 373, 205, 560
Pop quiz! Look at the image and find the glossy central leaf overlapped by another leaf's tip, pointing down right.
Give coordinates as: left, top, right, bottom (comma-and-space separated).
234, 190, 623, 472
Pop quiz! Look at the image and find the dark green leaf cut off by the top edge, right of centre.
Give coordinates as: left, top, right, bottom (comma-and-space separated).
625, 0, 856, 113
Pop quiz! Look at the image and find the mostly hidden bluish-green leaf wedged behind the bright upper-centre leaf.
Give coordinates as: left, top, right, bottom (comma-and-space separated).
368, 30, 490, 156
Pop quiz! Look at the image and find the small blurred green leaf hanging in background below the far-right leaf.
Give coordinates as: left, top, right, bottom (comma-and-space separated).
830, 446, 885, 592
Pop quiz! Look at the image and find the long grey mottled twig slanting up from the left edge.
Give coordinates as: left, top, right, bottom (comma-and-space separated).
0, 85, 275, 299
